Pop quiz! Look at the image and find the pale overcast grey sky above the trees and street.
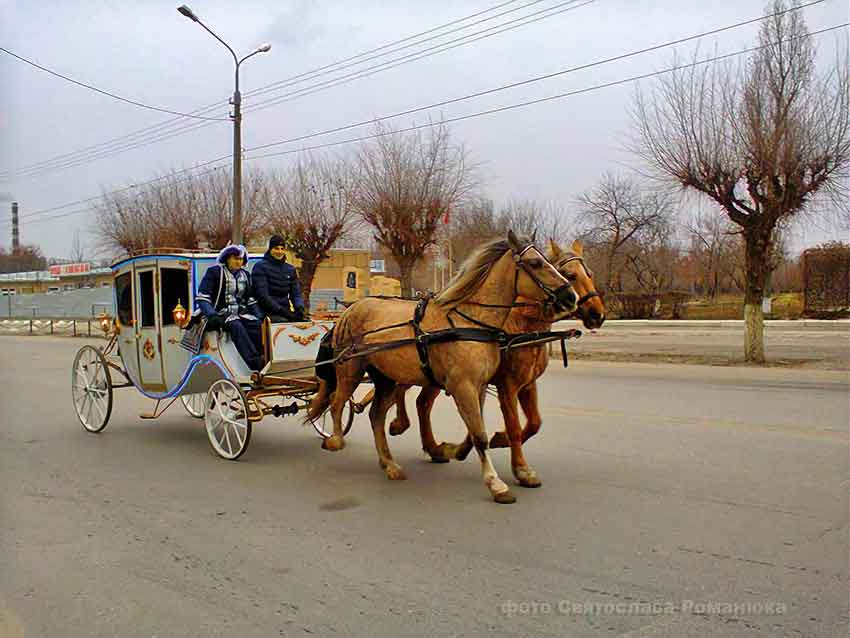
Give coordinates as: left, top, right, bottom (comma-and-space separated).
0, 0, 848, 257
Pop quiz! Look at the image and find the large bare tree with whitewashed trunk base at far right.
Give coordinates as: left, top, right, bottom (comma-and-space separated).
634, 0, 850, 362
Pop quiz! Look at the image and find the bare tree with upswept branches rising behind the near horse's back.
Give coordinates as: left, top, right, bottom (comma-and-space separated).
353, 124, 473, 294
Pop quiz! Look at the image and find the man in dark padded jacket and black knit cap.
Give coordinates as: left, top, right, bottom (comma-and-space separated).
251, 235, 304, 323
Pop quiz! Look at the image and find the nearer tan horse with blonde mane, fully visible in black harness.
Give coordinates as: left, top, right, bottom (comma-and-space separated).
307, 232, 578, 503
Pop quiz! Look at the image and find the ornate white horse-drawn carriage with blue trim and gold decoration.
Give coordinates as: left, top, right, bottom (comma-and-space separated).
71, 250, 370, 460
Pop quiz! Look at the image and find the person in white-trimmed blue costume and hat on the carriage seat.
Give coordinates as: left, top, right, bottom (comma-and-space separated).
194, 246, 263, 370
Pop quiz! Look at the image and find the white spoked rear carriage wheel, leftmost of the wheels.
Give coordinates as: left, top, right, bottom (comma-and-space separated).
71, 346, 112, 432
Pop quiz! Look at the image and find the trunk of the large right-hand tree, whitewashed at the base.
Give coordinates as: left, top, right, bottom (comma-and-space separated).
744, 227, 773, 363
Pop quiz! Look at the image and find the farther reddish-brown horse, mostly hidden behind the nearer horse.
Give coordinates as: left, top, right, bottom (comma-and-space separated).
390, 240, 605, 487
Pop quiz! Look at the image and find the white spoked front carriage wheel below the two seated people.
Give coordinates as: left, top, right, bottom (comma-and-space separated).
204, 379, 251, 461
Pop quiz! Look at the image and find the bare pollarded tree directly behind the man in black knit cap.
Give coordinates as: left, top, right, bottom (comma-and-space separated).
261, 157, 356, 310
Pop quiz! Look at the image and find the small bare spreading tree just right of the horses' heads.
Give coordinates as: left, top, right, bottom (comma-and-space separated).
578, 174, 673, 291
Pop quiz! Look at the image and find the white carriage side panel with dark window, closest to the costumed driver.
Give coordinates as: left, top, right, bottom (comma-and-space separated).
159, 260, 193, 390
